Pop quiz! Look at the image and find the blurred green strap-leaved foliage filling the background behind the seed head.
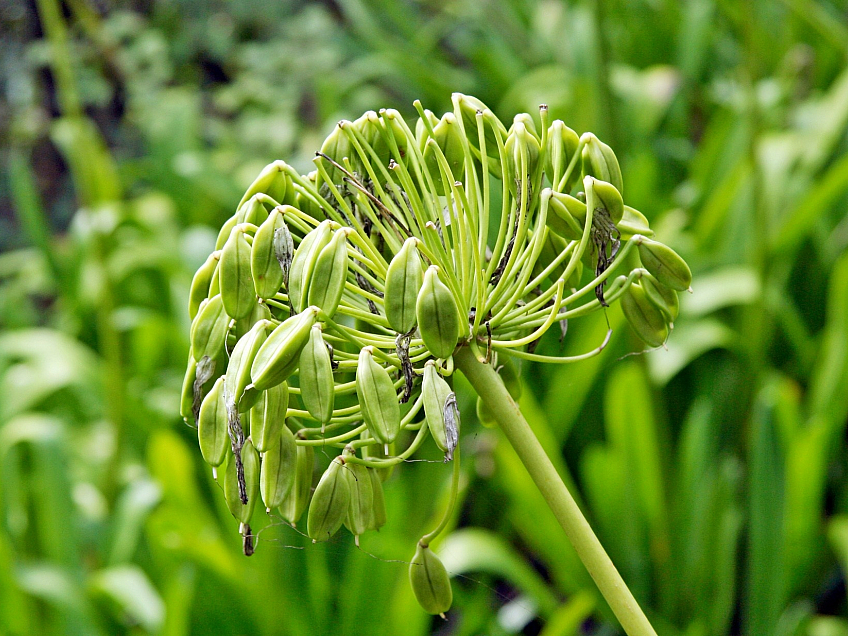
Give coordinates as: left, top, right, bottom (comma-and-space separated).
0, 0, 848, 636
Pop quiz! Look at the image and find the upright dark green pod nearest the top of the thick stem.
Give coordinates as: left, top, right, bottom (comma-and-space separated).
415, 265, 462, 358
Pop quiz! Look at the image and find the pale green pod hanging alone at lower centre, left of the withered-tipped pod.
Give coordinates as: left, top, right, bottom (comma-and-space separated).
356, 347, 400, 444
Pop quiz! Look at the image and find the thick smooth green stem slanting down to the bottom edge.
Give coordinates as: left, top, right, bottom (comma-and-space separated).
454, 347, 656, 636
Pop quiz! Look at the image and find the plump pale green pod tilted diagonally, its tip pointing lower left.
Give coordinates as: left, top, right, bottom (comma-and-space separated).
250, 307, 318, 391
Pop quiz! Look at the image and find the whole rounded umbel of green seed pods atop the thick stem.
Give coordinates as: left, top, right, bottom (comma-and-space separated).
182, 94, 691, 614
